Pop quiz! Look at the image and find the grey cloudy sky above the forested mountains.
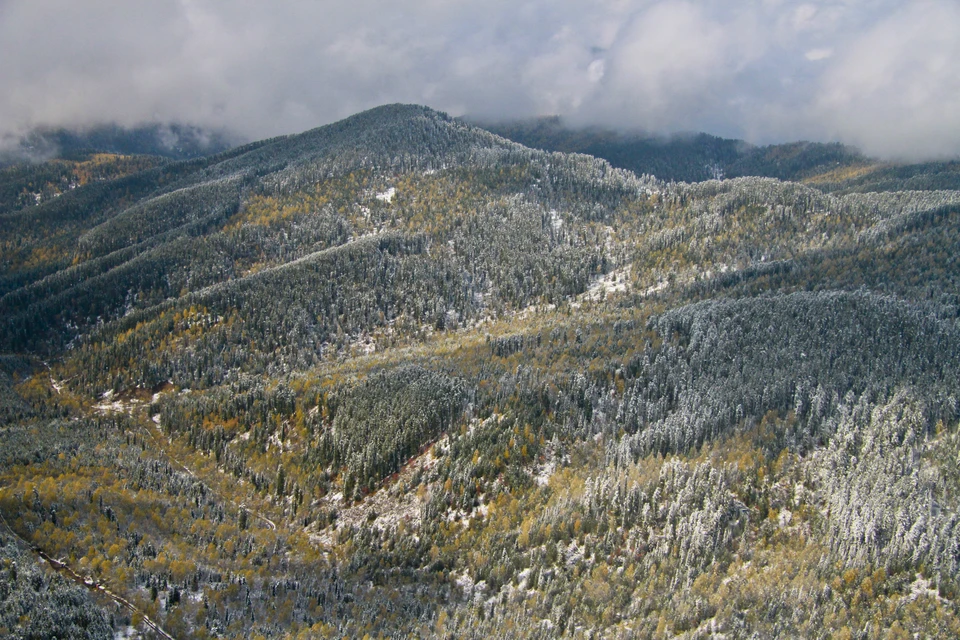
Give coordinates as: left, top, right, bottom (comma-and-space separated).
0, 0, 960, 159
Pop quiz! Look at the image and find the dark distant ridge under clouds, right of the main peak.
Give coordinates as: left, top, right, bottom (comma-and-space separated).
477, 116, 960, 193
